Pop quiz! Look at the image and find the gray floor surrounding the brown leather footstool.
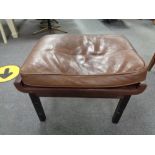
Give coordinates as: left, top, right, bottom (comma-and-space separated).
0, 20, 155, 134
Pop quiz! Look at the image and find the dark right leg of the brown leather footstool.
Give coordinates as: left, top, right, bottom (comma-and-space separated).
112, 96, 131, 123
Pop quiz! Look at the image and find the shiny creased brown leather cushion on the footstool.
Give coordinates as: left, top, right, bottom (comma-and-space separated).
20, 34, 146, 88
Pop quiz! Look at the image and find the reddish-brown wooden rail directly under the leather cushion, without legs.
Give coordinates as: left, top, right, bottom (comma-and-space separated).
14, 76, 146, 98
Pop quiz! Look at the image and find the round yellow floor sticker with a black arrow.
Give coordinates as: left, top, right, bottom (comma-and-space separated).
0, 65, 20, 82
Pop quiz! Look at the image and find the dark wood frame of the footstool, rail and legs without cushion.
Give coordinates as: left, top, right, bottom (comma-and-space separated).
14, 75, 146, 123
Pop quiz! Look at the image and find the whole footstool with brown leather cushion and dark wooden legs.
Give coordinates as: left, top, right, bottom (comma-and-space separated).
14, 34, 147, 123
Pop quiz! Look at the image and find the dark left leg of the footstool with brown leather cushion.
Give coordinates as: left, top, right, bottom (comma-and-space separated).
29, 93, 46, 121
